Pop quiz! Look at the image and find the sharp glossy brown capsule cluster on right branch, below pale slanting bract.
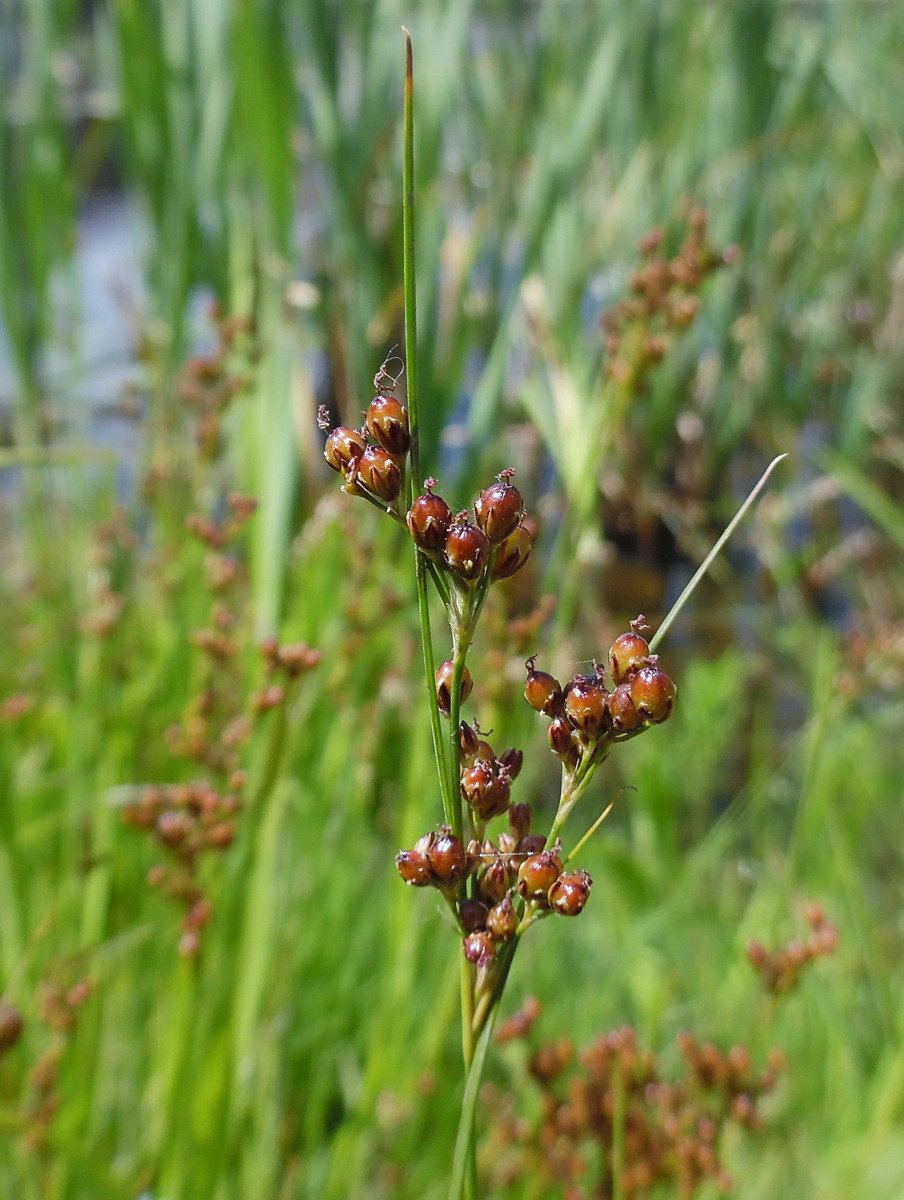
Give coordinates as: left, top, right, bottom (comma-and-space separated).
525, 617, 677, 769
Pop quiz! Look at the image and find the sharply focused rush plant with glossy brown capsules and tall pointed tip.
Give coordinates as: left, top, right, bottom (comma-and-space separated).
318, 31, 774, 1200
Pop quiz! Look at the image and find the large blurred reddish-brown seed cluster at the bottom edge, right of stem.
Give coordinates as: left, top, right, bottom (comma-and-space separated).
495, 997, 783, 1198
